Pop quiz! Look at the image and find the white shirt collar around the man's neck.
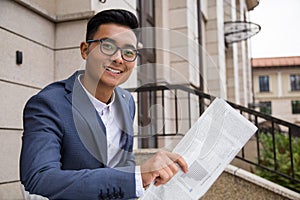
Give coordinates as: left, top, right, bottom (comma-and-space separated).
78, 74, 115, 112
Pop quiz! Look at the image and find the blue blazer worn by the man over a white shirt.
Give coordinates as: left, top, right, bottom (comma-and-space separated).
20, 72, 136, 200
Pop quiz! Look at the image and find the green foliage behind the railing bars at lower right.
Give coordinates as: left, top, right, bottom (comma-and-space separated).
255, 132, 300, 192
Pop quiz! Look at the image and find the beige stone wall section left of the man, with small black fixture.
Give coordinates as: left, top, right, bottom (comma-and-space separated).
0, 0, 55, 195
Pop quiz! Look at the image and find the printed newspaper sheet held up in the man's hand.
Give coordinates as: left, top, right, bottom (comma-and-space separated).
141, 98, 257, 200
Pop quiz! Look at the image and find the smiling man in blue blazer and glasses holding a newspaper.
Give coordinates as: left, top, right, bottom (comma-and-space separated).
20, 10, 187, 200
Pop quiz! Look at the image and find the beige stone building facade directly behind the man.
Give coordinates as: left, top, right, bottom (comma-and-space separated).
0, 0, 258, 199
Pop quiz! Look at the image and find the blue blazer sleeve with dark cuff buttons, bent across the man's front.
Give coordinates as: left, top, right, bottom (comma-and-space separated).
20, 95, 136, 200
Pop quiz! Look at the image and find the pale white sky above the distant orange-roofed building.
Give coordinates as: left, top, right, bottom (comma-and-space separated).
250, 0, 300, 58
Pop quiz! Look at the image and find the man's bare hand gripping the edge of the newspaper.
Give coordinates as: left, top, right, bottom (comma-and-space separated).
141, 151, 188, 187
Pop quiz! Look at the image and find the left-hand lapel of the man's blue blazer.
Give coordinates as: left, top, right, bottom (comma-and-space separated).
66, 74, 107, 165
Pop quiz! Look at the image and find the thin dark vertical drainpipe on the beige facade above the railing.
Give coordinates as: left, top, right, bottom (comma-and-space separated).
197, 0, 204, 114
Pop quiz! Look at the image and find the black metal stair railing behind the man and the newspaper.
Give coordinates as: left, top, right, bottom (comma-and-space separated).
127, 85, 300, 192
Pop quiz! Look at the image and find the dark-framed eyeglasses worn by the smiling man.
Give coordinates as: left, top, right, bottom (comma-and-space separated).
86, 39, 138, 62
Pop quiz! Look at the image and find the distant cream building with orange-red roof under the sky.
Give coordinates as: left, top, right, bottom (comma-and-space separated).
252, 56, 300, 125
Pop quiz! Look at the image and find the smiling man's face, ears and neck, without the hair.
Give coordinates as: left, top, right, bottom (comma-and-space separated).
80, 24, 138, 103
